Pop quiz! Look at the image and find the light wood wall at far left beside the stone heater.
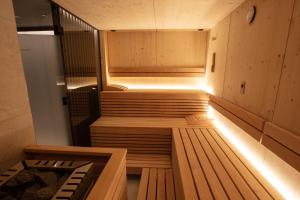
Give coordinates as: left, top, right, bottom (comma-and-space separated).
0, 0, 35, 172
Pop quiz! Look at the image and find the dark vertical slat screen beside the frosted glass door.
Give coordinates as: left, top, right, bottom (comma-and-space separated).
56, 6, 101, 146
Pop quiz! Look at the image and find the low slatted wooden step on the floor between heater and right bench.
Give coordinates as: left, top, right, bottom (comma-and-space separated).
137, 168, 175, 200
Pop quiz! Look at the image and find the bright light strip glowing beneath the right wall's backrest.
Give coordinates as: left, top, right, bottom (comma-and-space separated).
208, 106, 300, 199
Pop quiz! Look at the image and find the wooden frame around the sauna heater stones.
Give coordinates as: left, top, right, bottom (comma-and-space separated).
24, 144, 127, 200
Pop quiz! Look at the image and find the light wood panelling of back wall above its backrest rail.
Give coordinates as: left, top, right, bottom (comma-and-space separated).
108, 31, 207, 67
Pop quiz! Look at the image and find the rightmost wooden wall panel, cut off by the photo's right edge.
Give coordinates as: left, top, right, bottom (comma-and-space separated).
273, 0, 300, 136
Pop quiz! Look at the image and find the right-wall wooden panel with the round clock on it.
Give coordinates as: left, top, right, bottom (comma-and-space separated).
223, 0, 294, 120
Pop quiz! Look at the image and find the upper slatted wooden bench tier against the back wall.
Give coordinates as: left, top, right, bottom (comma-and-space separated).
100, 90, 209, 117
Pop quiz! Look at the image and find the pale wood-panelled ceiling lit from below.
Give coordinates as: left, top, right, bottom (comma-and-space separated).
53, 0, 244, 30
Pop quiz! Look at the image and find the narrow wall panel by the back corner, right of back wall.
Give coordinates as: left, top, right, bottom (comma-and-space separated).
206, 16, 230, 96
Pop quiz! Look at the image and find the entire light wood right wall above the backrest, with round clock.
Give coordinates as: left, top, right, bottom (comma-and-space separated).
206, 0, 300, 135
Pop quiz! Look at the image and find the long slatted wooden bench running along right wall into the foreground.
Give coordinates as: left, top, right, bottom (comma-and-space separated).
172, 128, 282, 200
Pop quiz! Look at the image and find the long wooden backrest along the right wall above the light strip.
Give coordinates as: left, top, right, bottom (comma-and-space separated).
210, 95, 300, 171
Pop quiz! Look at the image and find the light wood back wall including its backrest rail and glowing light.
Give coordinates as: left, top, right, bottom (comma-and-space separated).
102, 30, 207, 89
